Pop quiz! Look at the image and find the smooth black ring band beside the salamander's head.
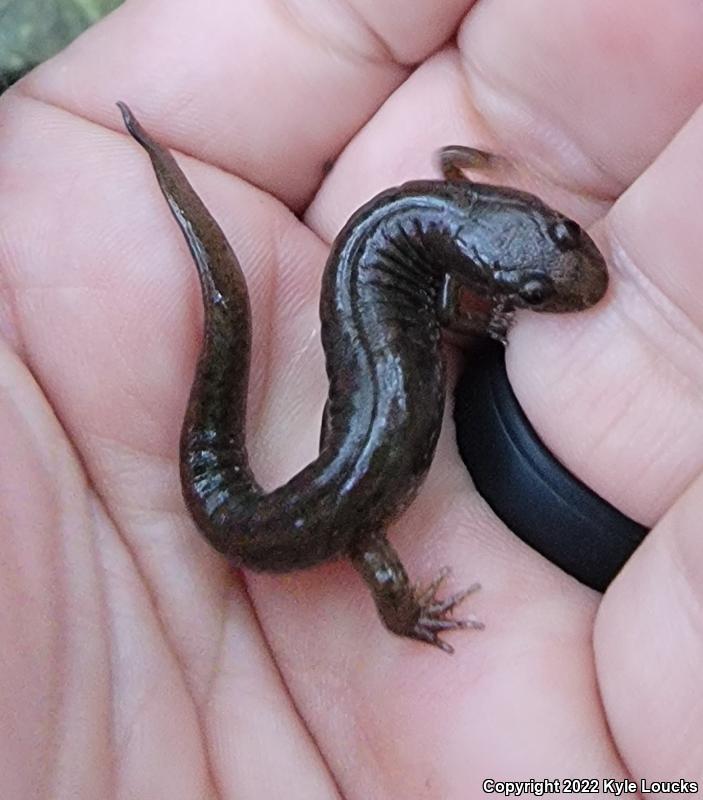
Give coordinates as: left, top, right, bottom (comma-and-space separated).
454, 342, 648, 591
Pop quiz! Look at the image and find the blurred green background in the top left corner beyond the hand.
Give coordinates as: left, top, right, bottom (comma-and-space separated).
0, 0, 123, 93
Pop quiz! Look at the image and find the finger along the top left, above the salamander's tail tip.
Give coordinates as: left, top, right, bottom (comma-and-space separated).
22, 0, 470, 207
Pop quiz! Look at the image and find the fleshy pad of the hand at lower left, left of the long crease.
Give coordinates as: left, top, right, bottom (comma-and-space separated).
0, 343, 209, 797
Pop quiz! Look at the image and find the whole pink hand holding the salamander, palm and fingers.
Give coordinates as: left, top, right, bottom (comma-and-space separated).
0, 0, 703, 800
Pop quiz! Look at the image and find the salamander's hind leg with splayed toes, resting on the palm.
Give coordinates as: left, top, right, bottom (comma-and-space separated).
350, 534, 483, 653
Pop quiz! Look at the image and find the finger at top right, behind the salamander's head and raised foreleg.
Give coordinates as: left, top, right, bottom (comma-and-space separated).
308, 0, 703, 240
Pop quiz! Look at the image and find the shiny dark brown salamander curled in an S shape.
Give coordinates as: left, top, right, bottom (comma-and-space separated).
119, 103, 608, 652
